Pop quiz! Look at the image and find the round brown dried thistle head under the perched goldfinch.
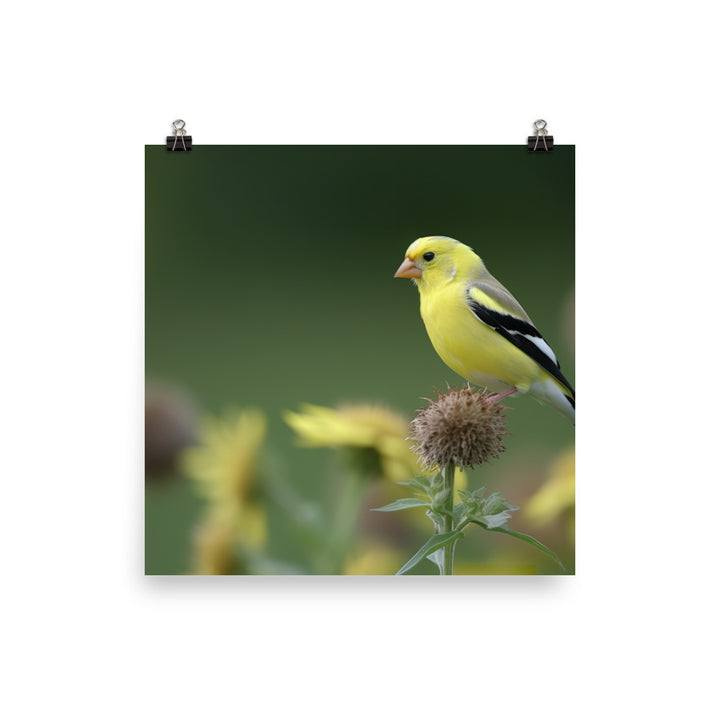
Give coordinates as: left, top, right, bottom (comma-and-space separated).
410, 386, 509, 468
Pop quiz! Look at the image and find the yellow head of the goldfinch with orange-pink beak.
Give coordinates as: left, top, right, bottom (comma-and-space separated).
394, 235, 482, 288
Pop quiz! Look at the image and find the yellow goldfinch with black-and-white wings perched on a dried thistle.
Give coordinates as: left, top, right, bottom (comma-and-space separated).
395, 236, 575, 423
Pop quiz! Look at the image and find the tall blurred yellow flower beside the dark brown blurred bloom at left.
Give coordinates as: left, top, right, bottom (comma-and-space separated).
182, 409, 267, 547
